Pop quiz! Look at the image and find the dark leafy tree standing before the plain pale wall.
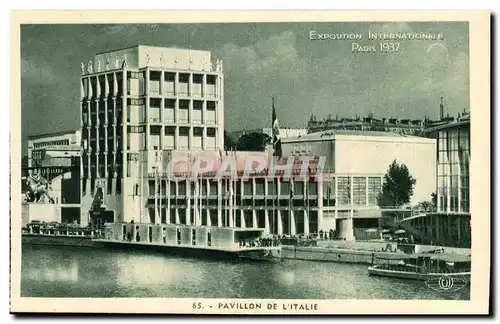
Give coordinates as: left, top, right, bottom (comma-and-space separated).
378, 160, 417, 207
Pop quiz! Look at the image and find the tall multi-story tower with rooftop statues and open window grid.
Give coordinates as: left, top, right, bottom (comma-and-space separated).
80, 45, 224, 227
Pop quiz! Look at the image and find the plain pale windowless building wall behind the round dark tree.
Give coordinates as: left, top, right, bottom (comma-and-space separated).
282, 130, 436, 205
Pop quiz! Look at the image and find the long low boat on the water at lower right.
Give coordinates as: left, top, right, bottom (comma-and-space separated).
368, 253, 471, 281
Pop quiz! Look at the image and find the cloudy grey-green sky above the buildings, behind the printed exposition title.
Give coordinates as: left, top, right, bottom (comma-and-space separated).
20, 22, 469, 151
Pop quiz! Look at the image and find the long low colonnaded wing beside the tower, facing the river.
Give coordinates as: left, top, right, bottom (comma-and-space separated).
115, 151, 382, 239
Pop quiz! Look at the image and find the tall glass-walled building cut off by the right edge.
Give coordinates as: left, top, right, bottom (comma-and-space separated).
388, 117, 472, 248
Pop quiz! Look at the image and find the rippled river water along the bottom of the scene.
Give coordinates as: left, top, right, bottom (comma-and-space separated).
21, 245, 470, 299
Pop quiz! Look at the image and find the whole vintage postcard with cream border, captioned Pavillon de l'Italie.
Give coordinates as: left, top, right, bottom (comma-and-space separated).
10, 11, 490, 315
